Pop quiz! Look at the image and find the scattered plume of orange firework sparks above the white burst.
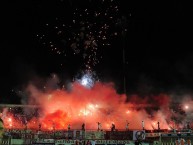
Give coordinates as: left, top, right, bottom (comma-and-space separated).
37, 0, 121, 72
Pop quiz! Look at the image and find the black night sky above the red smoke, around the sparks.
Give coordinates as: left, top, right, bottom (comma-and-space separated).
0, 0, 193, 104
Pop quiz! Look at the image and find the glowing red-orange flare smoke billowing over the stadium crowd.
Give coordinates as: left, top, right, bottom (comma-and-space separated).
1, 75, 192, 130
